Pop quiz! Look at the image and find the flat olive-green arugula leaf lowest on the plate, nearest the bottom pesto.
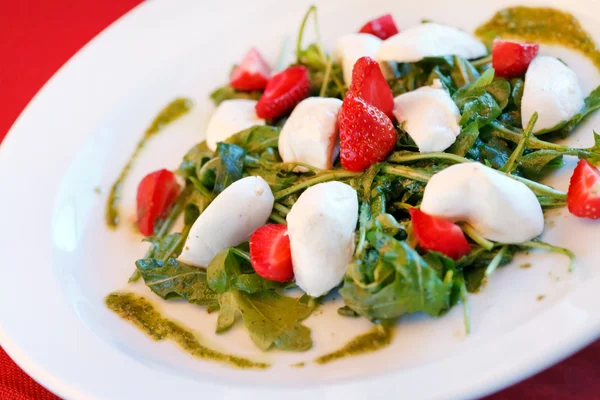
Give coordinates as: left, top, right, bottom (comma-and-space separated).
232, 290, 312, 351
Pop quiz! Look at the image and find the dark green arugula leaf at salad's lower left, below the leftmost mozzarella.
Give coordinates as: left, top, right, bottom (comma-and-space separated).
135, 258, 219, 312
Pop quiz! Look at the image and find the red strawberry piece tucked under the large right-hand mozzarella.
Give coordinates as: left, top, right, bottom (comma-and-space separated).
408, 208, 471, 260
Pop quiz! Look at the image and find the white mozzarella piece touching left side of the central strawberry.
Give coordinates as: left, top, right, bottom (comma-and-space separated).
279, 97, 342, 171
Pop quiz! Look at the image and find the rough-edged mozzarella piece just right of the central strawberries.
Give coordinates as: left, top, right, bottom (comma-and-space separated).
394, 79, 460, 153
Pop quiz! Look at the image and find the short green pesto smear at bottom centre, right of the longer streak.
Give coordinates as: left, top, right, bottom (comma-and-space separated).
315, 325, 393, 364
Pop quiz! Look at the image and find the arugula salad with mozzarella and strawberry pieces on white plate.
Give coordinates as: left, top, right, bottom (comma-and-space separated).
107, 7, 600, 359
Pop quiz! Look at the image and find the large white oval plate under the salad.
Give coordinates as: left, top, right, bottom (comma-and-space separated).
0, 0, 600, 399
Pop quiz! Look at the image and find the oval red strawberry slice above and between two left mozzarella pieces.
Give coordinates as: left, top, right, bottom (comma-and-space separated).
256, 65, 310, 119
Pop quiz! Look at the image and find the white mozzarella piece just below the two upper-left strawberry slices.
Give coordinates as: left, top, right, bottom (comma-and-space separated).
206, 99, 265, 151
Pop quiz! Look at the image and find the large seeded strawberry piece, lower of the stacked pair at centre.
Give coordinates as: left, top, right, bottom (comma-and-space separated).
338, 94, 397, 171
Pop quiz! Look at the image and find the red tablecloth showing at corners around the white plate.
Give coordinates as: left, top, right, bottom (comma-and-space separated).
0, 0, 600, 400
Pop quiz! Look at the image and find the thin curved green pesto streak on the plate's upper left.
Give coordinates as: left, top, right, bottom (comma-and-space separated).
105, 97, 192, 229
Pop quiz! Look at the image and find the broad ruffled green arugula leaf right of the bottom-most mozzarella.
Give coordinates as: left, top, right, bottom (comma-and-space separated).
340, 230, 453, 320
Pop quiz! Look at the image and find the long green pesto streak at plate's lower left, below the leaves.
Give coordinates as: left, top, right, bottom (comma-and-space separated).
106, 292, 270, 369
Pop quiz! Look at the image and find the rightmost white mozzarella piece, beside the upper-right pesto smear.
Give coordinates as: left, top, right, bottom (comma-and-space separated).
521, 56, 584, 132
